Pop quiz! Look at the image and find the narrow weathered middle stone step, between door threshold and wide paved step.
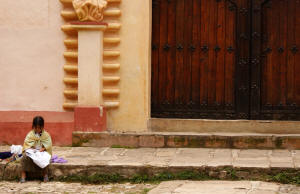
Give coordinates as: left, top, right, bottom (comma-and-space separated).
72, 132, 300, 149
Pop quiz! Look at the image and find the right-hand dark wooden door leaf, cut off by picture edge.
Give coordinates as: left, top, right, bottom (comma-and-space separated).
251, 0, 300, 120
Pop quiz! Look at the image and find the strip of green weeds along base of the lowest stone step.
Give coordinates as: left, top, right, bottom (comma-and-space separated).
55, 167, 300, 185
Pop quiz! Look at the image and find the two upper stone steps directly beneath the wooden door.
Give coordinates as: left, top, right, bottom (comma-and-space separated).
72, 118, 300, 149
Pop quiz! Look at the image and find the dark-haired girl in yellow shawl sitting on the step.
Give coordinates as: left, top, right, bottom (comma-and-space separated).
21, 116, 52, 183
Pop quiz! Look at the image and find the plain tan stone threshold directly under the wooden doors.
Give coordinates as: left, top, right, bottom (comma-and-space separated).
148, 118, 300, 134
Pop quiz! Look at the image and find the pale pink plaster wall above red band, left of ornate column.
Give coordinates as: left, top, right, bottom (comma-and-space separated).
0, 0, 64, 111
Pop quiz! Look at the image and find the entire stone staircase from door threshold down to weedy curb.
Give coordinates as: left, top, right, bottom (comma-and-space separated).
0, 119, 300, 184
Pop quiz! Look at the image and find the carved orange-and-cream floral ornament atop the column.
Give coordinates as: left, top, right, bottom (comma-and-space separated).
72, 0, 107, 22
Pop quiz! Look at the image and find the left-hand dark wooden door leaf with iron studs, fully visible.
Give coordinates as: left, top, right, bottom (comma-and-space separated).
151, 0, 250, 119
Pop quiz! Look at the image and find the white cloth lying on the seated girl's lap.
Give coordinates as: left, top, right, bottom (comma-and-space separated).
26, 148, 51, 168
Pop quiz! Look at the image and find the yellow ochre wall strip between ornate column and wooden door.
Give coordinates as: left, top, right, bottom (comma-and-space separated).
108, 0, 151, 131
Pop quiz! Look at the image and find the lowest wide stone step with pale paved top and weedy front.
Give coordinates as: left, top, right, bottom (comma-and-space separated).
0, 147, 300, 183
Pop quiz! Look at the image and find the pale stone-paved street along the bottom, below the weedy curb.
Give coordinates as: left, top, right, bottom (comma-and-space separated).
0, 181, 300, 194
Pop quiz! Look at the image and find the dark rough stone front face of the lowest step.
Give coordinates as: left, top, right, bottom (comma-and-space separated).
0, 163, 300, 182
